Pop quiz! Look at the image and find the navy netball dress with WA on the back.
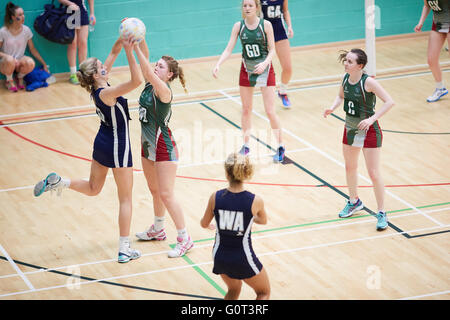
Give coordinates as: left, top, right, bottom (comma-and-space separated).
213, 189, 263, 279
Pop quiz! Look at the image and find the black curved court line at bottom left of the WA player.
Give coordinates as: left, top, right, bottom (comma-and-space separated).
0, 256, 223, 300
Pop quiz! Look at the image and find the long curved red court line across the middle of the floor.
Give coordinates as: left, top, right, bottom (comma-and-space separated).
0, 120, 450, 188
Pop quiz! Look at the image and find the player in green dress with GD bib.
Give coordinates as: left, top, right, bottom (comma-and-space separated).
213, 0, 285, 162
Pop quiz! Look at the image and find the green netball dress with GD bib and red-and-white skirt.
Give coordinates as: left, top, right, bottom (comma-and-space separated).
239, 19, 275, 87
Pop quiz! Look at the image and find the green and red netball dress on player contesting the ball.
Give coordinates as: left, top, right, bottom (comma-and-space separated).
139, 83, 178, 161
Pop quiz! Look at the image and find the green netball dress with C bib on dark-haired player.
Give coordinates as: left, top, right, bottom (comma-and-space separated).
342, 73, 383, 148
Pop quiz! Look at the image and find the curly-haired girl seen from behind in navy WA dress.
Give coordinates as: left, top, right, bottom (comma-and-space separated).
200, 153, 270, 300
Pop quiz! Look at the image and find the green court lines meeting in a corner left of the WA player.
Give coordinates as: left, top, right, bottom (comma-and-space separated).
169, 202, 450, 296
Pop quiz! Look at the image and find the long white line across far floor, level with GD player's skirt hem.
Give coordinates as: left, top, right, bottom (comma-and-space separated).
0, 60, 450, 120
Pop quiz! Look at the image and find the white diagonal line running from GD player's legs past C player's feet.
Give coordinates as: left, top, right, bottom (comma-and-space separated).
218, 90, 442, 226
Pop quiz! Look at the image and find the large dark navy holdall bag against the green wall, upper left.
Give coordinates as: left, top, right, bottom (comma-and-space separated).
34, 0, 79, 44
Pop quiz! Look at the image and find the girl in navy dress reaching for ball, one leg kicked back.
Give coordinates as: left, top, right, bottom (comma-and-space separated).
34, 39, 142, 262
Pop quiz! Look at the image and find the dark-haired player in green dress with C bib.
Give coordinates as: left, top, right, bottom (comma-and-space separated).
323, 49, 394, 230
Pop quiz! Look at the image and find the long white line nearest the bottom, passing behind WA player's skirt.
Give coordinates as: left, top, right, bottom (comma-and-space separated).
0, 225, 450, 297
